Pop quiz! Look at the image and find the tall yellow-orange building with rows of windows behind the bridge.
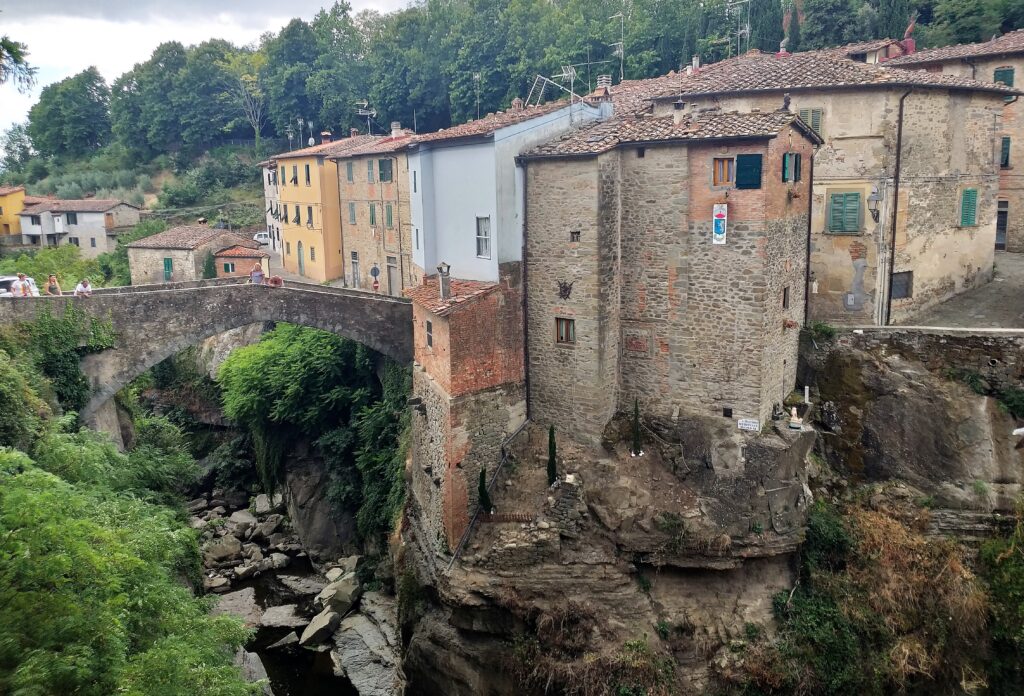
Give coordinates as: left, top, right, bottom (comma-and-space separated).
273, 134, 371, 282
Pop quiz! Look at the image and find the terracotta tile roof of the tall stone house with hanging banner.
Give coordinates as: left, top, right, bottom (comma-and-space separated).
523, 111, 820, 159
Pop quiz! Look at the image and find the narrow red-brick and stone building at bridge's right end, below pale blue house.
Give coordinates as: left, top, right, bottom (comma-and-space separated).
406, 273, 526, 550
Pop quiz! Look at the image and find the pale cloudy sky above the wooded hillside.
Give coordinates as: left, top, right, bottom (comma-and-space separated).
0, 0, 408, 138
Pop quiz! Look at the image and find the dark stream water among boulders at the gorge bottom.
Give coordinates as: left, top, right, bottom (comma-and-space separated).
238, 558, 359, 696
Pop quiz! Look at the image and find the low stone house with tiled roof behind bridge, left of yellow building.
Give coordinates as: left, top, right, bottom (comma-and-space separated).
128, 225, 259, 286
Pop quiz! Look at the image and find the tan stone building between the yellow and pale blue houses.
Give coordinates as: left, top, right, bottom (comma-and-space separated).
332, 123, 420, 296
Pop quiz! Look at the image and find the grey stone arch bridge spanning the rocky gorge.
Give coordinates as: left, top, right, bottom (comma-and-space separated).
0, 278, 413, 423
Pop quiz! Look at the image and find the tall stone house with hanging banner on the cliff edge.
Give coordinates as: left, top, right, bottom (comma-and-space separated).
521, 111, 821, 442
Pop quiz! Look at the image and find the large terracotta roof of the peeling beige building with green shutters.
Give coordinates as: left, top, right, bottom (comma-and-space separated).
639, 50, 1017, 99
